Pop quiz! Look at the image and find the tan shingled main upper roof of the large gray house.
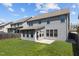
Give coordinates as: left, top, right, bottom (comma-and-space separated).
28, 9, 69, 22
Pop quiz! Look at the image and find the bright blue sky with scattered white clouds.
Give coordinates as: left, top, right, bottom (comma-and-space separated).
0, 3, 79, 23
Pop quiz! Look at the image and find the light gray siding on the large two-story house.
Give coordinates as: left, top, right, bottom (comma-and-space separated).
21, 14, 69, 40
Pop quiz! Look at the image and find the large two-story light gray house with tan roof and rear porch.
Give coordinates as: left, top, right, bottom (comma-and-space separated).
20, 9, 70, 41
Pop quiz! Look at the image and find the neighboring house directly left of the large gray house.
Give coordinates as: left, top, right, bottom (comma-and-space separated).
8, 17, 31, 33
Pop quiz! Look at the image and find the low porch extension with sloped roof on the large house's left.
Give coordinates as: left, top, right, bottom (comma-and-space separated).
20, 26, 44, 41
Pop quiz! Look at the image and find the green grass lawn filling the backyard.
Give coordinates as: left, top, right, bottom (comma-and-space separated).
0, 39, 73, 56
